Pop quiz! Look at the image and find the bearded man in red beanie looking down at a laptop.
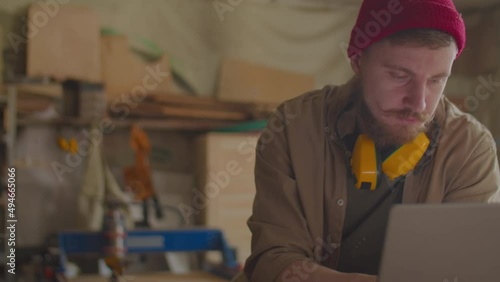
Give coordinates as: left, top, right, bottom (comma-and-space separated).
244, 0, 500, 282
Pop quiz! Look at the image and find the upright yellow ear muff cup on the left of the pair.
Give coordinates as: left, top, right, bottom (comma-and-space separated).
351, 134, 379, 190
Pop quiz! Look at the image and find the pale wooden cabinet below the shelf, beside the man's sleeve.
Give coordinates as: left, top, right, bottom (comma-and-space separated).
195, 133, 258, 264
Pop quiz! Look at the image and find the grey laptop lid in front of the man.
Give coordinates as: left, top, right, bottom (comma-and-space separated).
378, 203, 500, 282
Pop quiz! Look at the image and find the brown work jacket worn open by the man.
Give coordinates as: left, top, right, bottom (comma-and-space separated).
244, 78, 500, 282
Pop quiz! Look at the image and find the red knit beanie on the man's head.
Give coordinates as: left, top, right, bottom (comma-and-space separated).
347, 0, 465, 58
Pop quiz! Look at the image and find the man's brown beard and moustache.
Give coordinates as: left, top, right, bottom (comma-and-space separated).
358, 96, 432, 148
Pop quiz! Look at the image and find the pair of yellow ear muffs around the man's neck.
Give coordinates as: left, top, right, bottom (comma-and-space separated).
351, 132, 430, 190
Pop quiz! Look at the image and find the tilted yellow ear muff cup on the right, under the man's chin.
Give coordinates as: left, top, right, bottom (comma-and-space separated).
382, 132, 430, 180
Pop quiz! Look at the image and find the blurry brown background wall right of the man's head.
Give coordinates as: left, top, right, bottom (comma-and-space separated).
445, 6, 500, 157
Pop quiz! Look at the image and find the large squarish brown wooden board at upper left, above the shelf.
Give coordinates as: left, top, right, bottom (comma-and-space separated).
27, 3, 101, 82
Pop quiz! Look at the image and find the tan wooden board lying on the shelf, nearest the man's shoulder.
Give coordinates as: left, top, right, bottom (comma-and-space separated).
217, 59, 315, 104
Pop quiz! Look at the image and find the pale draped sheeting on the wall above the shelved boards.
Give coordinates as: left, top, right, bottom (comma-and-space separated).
0, 0, 357, 95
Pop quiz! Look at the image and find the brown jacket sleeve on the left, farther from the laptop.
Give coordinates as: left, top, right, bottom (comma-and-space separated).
244, 106, 313, 282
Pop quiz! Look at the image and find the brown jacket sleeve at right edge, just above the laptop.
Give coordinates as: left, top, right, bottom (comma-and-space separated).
444, 133, 500, 202
